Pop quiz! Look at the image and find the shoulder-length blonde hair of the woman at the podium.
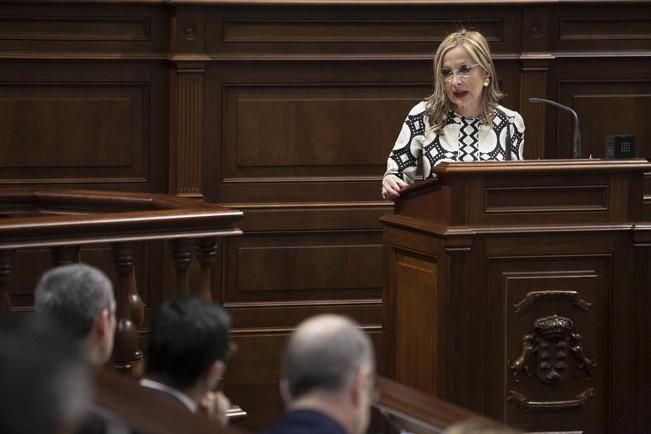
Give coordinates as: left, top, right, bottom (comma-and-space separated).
425, 29, 504, 133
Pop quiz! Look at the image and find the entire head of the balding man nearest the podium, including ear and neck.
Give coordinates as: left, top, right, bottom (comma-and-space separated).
281, 315, 375, 434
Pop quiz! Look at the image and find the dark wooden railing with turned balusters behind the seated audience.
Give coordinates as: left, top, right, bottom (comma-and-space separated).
0, 188, 242, 376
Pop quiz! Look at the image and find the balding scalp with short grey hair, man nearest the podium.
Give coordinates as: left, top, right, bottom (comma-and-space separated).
284, 315, 374, 399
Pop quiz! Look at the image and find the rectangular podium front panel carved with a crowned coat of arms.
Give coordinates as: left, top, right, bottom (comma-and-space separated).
487, 248, 612, 433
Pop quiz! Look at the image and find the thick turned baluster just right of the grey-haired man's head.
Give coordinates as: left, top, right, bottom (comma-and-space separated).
112, 243, 144, 378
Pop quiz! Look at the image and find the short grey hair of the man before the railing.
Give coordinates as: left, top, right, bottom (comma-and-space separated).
34, 264, 115, 339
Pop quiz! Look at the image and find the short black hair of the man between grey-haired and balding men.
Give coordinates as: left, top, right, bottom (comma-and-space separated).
145, 296, 230, 390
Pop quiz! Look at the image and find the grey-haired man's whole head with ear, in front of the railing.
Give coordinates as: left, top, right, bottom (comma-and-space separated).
34, 264, 116, 366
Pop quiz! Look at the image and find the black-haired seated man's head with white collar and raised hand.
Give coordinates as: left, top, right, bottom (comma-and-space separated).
140, 296, 232, 426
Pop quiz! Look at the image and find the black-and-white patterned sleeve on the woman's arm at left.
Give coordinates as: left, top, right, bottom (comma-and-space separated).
384, 103, 425, 184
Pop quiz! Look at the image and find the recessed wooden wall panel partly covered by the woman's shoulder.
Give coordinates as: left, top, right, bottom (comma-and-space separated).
224, 84, 426, 181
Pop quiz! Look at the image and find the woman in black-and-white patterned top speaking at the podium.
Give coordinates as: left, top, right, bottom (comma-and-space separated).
382, 29, 524, 199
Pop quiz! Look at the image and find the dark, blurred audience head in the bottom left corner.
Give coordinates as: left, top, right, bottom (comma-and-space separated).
0, 319, 91, 434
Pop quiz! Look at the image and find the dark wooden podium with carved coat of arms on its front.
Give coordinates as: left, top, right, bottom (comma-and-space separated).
382, 160, 651, 433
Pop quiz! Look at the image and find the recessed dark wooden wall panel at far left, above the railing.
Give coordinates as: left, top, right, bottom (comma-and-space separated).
0, 82, 149, 180
